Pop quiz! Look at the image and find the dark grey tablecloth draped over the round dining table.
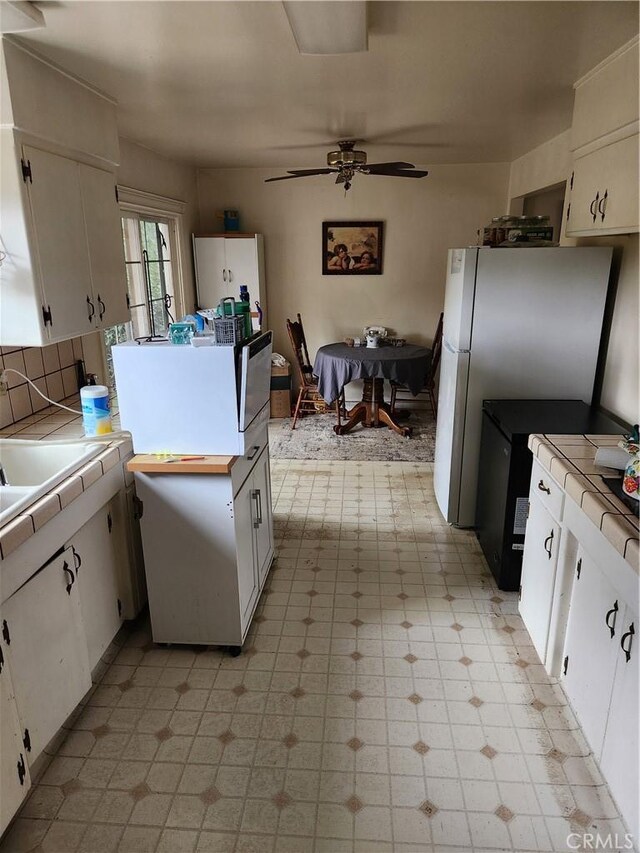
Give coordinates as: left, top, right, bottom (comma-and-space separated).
313, 343, 431, 403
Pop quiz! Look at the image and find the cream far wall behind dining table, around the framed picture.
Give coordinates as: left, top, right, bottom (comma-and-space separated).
198, 164, 509, 359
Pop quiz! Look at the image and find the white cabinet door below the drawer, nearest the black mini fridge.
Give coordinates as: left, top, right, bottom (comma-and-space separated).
518, 490, 561, 663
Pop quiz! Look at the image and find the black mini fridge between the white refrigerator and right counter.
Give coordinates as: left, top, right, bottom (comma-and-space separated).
476, 400, 627, 590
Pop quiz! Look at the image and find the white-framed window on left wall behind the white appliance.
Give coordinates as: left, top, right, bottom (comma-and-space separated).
104, 188, 182, 386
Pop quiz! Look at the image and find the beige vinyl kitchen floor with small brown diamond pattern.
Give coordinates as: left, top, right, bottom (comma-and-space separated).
0, 461, 624, 853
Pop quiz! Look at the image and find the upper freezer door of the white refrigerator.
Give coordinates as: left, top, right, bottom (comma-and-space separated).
443, 249, 478, 351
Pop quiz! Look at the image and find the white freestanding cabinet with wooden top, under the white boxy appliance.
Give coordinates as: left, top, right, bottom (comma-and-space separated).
129, 427, 273, 653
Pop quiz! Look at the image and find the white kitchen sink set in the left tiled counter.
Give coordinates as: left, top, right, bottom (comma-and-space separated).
0, 439, 104, 528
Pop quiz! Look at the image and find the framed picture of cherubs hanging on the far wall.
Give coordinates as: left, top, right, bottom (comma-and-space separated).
322, 222, 383, 275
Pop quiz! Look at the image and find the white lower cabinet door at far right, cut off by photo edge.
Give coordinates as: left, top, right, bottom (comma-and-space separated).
600, 607, 640, 840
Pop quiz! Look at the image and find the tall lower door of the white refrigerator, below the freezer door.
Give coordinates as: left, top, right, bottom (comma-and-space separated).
433, 341, 469, 524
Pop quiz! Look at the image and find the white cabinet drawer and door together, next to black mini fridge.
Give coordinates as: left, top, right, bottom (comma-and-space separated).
518, 460, 563, 663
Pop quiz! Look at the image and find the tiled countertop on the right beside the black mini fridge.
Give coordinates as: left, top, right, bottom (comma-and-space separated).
529, 435, 640, 574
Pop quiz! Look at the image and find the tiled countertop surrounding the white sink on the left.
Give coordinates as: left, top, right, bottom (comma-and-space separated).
0, 394, 133, 560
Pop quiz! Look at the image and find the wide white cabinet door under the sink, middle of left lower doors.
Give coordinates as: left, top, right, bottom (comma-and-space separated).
2, 548, 91, 764
